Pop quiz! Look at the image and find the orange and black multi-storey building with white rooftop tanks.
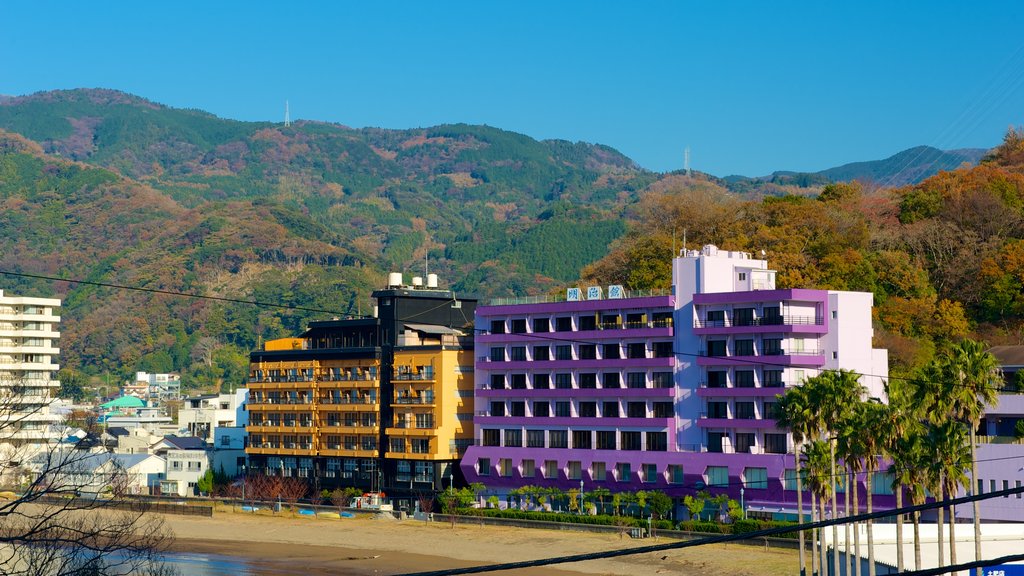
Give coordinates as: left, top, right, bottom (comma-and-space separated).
246, 275, 476, 496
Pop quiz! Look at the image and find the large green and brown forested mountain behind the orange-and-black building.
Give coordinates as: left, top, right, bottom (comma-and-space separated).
0, 90, 657, 381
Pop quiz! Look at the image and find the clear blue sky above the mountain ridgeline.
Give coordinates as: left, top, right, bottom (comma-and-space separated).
0, 0, 1024, 175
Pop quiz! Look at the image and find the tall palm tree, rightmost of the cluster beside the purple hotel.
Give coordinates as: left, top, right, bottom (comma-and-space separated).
943, 340, 1002, 576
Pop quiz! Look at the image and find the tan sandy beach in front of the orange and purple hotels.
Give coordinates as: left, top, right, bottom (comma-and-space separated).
164, 510, 798, 576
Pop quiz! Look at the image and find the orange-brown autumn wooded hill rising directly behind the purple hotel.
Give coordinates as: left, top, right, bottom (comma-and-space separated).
584, 130, 1024, 375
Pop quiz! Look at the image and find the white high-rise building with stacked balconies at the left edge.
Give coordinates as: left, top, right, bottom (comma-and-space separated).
0, 290, 61, 459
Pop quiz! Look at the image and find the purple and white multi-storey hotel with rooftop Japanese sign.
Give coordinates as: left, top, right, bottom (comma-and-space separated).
462, 246, 888, 512
